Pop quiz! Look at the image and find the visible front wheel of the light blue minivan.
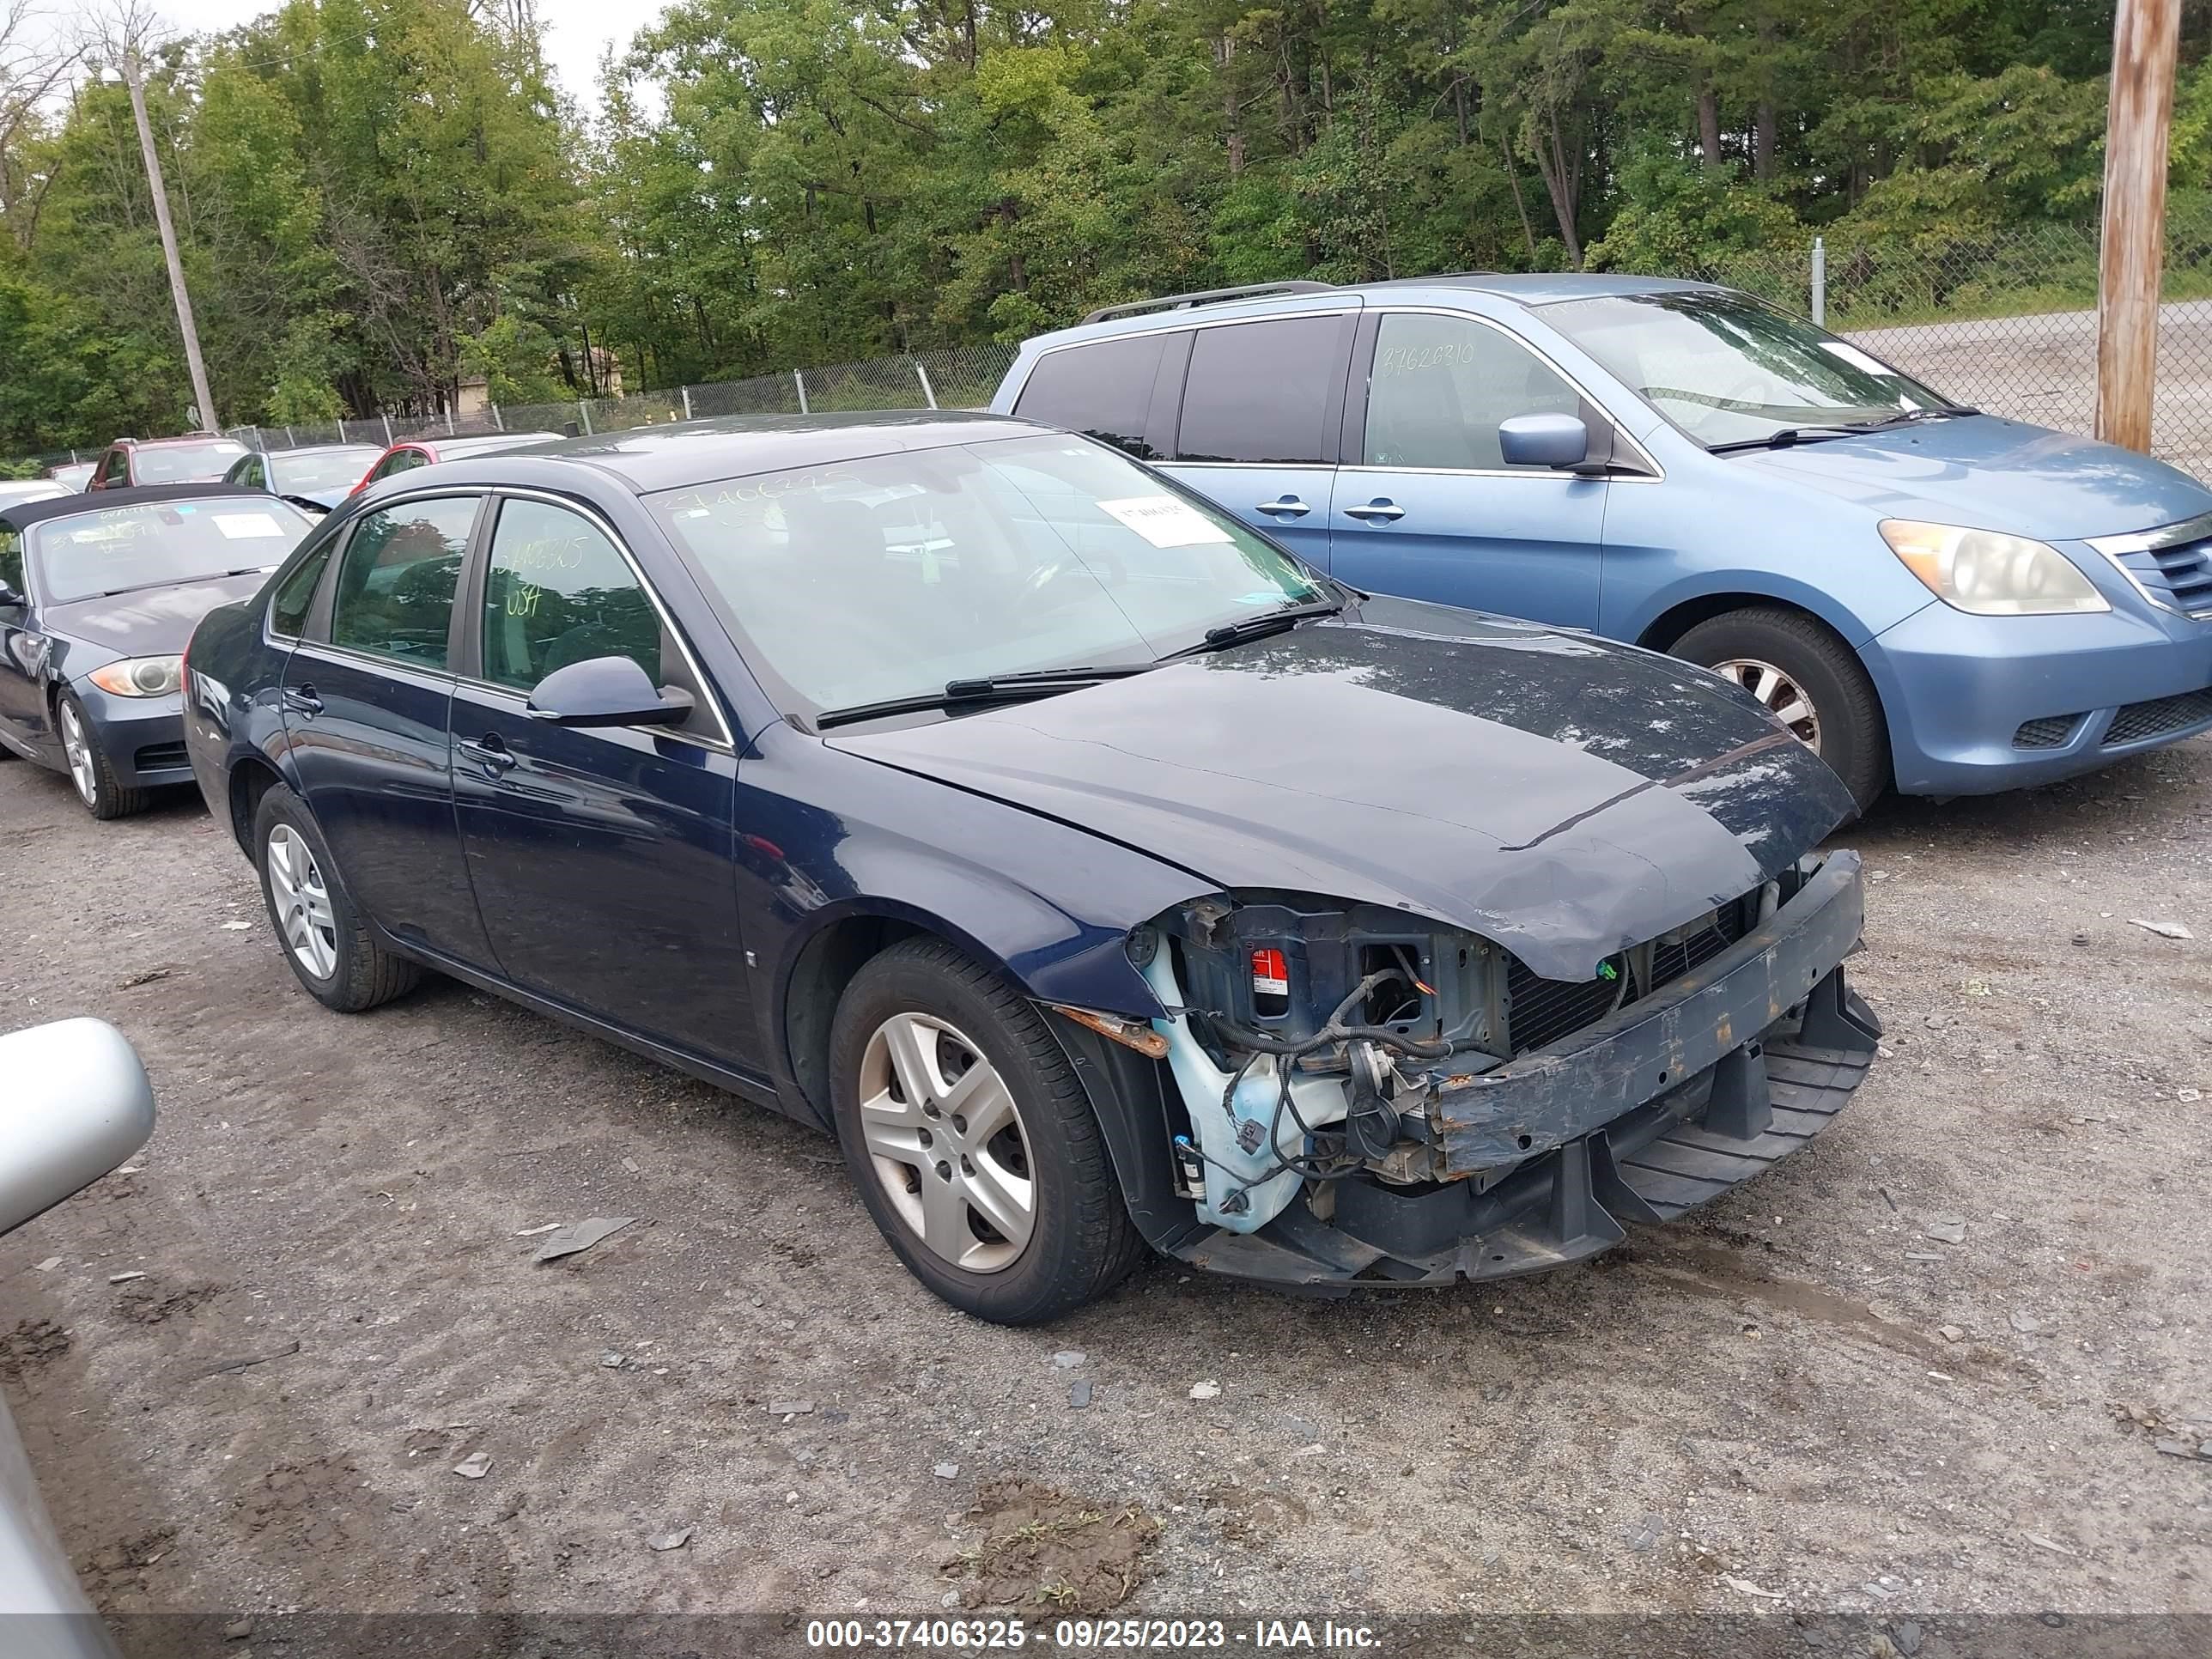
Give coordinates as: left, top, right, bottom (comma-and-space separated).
1674, 606, 1889, 811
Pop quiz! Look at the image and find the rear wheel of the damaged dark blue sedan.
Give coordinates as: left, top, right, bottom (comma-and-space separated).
254, 783, 422, 1013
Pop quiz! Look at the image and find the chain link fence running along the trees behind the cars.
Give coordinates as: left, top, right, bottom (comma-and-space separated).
13, 234, 2212, 477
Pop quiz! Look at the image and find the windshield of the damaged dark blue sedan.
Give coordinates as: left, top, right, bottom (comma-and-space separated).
648, 434, 1329, 710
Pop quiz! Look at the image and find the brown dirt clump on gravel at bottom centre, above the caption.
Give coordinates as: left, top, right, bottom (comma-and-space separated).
945, 1480, 1159, 1613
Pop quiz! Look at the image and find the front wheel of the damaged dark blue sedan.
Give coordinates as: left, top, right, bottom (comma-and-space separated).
830, 938, 1144, 1325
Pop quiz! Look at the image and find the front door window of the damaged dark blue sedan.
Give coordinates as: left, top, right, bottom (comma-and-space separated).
484, 500, 665, 690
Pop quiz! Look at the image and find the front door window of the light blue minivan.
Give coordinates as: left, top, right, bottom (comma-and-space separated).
1364, 312, 1582, 476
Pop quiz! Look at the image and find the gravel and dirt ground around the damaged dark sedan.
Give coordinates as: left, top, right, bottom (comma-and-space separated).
0, 741, 2212, 1627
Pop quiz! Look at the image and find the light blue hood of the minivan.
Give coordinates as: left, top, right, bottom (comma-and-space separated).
1725, 416, 2212, 542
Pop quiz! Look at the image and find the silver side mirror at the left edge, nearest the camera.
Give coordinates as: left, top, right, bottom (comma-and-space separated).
0, 1020, 153, 1232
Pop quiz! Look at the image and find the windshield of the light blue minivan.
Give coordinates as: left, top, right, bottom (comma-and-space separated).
1544, 295, 1951, 449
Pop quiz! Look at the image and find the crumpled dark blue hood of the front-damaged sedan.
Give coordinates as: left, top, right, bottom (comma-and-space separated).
827, 599, 1851, 980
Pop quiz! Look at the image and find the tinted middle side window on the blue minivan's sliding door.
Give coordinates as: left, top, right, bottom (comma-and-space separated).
1175, 316, 1345, 467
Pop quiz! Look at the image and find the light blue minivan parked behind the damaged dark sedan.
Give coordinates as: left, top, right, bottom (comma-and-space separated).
991, 274, 2212, 803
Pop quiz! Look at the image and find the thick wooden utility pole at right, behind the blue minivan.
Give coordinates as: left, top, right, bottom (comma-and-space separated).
2097, 0, 2181, 453
